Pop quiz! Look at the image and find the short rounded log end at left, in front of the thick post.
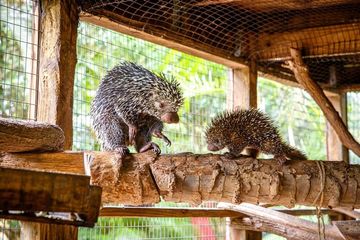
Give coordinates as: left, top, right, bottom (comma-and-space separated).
0, 117, 65, 152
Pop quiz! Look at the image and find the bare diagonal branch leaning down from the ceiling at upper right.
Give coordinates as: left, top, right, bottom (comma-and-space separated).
287, 48, 360, 156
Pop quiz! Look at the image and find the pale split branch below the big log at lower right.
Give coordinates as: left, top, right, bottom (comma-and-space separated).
219, 203, 344, 240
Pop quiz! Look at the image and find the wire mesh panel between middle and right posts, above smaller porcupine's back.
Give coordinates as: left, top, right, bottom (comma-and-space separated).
258, 78, 326, 160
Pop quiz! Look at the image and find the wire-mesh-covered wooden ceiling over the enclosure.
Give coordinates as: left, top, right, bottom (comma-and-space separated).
79, 0, 360, 89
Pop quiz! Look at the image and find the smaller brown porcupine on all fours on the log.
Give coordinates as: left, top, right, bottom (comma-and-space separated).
206, 109, 307, 164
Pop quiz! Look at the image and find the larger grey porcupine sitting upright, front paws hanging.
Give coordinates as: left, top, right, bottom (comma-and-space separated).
91, 62, 183, 158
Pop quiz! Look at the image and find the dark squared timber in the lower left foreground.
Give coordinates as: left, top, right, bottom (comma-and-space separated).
0, 167, 101, 225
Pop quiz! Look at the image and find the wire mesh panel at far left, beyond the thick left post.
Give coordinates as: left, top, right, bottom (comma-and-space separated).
0, 0, 39, 119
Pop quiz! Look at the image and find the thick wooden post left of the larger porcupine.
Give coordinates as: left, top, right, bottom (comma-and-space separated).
21, 0, 79, 240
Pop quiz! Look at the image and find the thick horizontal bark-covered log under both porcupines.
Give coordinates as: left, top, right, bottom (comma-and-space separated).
86, 152, 360, 208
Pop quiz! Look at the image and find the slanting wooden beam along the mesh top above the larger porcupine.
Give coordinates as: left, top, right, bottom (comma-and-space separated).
80, 10, 246, 68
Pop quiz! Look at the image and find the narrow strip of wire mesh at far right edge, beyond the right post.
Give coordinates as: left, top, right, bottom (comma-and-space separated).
347, 92, 360, 164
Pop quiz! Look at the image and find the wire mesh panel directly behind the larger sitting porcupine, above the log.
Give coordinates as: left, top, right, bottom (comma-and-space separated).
74, 22, 229, 153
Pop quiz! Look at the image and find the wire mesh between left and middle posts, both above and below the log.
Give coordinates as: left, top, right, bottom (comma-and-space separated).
73, 22, 229, 239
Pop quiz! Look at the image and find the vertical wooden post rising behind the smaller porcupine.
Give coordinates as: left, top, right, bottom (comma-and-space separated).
228, 59, 262, 240
